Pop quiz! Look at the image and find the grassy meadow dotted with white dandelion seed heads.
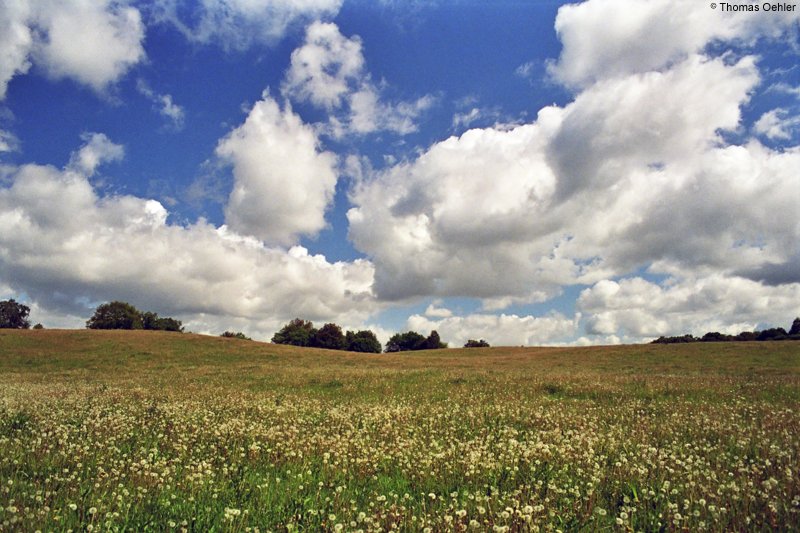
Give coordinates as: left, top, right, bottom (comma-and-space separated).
0, 330, 800, 531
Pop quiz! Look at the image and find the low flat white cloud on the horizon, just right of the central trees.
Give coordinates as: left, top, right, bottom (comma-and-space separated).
408, 313, 580, 348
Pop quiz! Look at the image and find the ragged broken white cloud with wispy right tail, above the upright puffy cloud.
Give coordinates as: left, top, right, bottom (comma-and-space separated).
282, 21, 435, 137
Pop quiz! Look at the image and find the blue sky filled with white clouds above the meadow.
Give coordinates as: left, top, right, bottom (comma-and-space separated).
0, 0, 800, 346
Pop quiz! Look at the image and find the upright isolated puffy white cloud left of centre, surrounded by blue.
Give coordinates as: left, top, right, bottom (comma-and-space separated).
216, 93, 337, 245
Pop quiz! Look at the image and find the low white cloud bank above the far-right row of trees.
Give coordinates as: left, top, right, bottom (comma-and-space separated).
578, 274, 800, 342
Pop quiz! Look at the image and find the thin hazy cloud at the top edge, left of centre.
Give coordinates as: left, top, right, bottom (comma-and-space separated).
156, 0, 342, 50
